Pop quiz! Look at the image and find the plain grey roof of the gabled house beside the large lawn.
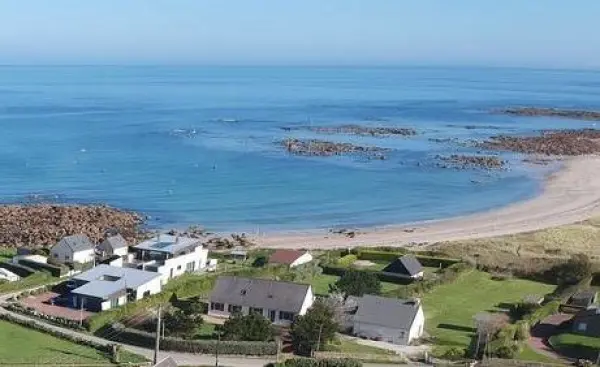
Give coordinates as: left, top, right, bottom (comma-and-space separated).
354, 295, 421, 330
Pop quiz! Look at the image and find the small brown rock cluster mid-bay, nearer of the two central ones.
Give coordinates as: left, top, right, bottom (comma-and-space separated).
281, 139, 389, 159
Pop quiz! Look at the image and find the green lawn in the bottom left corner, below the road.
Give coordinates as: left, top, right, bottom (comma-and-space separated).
0, 321, 116, 365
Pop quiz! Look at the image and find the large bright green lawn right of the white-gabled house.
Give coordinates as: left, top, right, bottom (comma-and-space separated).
423, 270, 554, 349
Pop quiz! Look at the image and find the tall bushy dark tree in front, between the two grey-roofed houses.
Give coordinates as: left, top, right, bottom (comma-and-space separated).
290, 300, 339, 356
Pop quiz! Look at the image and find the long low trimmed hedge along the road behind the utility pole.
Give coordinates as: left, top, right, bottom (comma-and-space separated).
103, 323, 277, 356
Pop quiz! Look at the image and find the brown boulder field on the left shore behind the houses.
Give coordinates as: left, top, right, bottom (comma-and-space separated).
0, 204, 144, 248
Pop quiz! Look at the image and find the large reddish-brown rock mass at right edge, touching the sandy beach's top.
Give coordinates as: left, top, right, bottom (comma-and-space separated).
480, 129, 600, 156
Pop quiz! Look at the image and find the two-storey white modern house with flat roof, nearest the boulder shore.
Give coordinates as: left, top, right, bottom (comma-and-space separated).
123, 235, 208, 284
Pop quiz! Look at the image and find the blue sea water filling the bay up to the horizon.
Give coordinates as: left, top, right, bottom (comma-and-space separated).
0, 66, 600, 231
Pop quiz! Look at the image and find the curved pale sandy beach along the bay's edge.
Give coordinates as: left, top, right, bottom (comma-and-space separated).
256, 156, 600, 249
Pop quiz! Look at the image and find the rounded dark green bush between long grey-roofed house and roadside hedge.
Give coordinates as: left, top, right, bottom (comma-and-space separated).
221, 312, 273, 341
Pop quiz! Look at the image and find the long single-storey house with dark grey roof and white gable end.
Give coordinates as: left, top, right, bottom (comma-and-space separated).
208, 276, 314, 326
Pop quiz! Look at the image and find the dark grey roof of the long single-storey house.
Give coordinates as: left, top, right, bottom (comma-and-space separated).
210, 276, 310, 313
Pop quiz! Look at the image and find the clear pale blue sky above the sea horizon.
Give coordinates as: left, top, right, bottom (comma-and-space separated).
0, 0, 600, 68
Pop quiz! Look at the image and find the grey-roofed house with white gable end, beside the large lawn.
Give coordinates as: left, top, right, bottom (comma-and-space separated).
351, 295, 425, 345
